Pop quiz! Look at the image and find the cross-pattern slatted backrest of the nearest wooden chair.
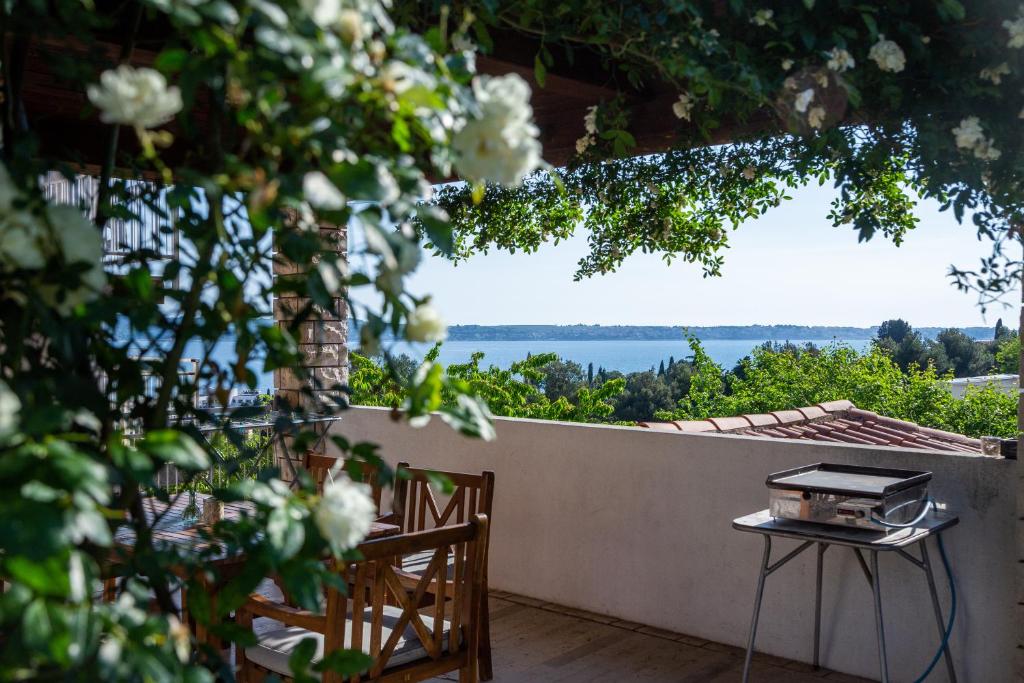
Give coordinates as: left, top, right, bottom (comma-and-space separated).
324, 515, 487, 683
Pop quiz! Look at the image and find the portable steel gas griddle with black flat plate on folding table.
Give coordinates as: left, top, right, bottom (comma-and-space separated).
765, 463, 932, 530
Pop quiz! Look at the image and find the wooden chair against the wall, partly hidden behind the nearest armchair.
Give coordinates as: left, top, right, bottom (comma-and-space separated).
393, 463, 495, 681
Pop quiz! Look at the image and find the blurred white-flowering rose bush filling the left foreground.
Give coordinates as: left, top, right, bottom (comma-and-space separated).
0, 0, 541, 682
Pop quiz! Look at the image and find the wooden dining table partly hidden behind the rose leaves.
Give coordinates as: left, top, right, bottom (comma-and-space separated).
112, 493, 401, 646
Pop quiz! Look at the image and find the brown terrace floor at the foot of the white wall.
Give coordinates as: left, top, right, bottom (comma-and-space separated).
434, 591, 865, 683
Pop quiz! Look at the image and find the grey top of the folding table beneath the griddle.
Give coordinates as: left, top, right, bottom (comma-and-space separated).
732, 510, 959, 551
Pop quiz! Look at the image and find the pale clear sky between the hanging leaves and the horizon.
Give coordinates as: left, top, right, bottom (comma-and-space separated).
387, 186, 1020, 327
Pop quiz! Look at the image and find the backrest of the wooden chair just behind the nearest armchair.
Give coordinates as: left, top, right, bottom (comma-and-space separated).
394, 463, 495, 533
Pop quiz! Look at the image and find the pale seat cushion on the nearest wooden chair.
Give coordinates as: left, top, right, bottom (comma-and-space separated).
246, 605, 449, 678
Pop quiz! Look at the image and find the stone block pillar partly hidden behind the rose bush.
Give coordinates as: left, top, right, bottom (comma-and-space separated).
273, 225, 348, 480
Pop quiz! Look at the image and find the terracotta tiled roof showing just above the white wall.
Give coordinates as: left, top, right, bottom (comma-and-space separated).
637, 400, 981, 454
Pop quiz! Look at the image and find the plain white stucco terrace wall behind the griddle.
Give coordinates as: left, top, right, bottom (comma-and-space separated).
336, 409, 1017, 682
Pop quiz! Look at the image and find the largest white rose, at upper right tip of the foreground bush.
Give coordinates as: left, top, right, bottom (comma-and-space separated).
452, 74, 541, 186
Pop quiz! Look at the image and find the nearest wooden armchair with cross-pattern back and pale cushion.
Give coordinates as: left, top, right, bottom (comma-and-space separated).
236, 515, 487, 683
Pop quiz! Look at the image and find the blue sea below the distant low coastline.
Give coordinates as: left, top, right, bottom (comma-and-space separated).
185, 339, 870, 391
